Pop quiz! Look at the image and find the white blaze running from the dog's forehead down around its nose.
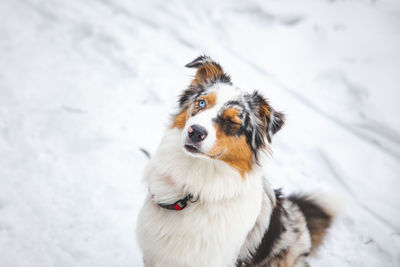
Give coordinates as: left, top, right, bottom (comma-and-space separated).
182, 83, 241, 153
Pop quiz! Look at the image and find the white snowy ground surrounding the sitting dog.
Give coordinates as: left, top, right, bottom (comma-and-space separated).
0, 0, 400, 267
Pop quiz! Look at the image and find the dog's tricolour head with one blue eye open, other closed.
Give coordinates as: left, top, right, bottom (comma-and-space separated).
172, 56, 284, 177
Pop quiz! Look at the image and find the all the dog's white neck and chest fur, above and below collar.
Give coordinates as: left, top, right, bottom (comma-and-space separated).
137, 130, 263, 267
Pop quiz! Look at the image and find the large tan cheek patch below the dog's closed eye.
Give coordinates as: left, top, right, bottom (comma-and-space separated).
209, 125, 253, 178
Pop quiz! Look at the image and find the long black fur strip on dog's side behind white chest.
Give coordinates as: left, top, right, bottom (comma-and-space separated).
236, 190, 287, 267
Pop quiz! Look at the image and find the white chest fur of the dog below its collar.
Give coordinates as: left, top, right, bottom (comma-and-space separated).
138, 186, 261, 267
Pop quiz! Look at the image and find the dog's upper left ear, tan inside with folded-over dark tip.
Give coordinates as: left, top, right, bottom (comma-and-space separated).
185, 55, 231, 86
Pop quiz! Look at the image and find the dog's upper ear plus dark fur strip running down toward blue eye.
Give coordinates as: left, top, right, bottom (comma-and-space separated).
179, 55, 231, 108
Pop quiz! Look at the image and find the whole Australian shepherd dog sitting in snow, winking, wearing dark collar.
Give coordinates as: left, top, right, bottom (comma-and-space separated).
136, 56, 335, 267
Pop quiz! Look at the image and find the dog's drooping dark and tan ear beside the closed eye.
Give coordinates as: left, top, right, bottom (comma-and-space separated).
251, 91, 285, 143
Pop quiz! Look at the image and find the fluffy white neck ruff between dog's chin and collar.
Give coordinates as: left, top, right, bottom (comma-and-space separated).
145, 129, 261, 203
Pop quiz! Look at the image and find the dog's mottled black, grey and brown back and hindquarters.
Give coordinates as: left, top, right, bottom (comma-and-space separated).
236, 191, 336, 267
